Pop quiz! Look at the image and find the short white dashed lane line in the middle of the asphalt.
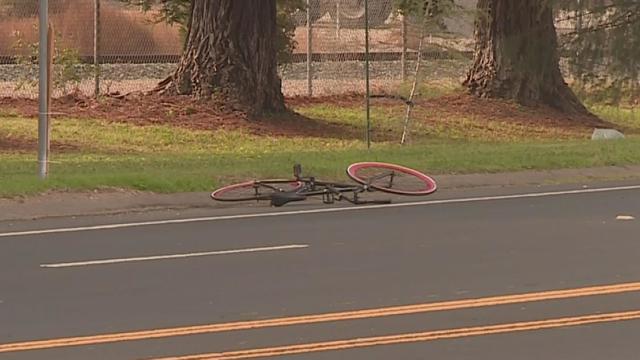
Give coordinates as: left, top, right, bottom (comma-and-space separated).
40, 245, 309, 268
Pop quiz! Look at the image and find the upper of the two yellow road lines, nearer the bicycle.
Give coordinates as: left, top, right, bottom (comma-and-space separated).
0, 282, 640, 353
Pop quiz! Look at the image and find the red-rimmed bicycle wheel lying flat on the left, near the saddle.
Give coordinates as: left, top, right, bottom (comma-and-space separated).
211, 180, 302, 201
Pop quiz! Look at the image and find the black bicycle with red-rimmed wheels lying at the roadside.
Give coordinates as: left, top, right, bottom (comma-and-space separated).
211, 162, 437, 207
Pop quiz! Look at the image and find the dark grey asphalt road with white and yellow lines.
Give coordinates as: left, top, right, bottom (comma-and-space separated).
0, 184, 640, 360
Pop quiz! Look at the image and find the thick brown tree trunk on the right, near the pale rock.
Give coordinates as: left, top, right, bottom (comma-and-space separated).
464, 0, 588, 113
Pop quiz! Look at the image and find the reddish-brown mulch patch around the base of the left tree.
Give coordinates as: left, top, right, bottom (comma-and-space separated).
0, 95, 362, 139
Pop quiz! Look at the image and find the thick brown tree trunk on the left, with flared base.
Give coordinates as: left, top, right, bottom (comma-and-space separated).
160, 0, 285, 115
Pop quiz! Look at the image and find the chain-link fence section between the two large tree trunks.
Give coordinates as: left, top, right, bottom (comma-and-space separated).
283, 0, 474, 95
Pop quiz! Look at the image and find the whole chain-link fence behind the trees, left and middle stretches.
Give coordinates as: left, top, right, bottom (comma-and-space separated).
0, 0, 475, 98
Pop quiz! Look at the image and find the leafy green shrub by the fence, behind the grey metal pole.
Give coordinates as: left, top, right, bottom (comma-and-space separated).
13, 28, 87, 93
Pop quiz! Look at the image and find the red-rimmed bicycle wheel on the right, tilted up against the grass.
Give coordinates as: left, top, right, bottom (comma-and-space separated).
347, 162, 437, 196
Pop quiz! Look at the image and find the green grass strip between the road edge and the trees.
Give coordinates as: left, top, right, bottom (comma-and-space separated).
0, 100, 640, 197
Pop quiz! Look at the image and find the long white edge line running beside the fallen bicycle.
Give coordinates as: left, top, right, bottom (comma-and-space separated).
0, 185, 640, 237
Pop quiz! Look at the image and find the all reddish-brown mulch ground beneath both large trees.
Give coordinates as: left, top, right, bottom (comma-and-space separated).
0, 93, 615, 143
